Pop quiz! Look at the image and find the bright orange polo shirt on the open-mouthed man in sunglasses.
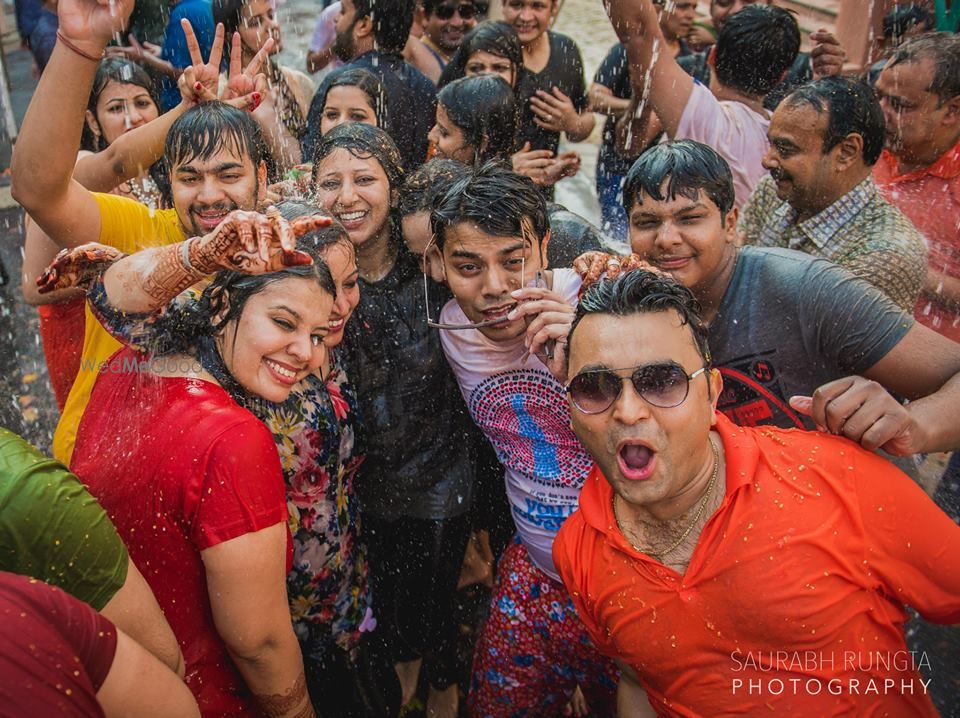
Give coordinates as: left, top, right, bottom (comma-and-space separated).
553, 415, 960, 718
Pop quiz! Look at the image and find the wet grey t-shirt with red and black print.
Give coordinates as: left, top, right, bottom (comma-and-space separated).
708, 245, 913, 429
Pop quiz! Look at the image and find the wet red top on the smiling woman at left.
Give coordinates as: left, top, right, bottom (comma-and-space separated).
71, 349, 292, 716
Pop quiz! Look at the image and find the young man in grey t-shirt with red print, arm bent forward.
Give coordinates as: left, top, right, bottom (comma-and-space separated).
580, 140, 960, 456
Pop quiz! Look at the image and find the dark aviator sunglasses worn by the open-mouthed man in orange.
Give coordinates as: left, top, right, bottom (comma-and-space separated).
567, 362, 707, 414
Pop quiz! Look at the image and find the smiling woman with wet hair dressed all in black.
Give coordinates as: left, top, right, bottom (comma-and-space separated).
313, 122, 475, 715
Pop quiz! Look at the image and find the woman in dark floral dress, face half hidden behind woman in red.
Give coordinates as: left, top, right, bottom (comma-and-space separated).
41, 201, 400, 718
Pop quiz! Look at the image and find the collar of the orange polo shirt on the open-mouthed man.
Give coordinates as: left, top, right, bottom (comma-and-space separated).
580, 412, 762, 560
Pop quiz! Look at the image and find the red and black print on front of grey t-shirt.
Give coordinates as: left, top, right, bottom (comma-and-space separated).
717, 350, 805, 429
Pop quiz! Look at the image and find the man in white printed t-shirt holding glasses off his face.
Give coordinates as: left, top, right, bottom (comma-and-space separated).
430, 165, 617, 718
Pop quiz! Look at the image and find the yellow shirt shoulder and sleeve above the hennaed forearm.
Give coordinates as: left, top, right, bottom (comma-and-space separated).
93, 192, 185, 254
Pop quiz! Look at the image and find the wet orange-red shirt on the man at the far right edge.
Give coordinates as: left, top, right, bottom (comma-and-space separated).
873, 141, 960, 341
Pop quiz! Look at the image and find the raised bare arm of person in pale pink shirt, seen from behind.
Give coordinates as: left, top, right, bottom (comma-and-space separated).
607, 0, 693, 137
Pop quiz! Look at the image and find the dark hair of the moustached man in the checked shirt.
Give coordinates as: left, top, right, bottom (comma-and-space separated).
783, 77, 886, 166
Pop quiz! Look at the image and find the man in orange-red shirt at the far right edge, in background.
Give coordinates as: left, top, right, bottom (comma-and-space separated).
873, 32, 960, 341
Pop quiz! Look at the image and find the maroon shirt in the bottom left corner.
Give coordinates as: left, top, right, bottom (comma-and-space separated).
0, 572, 117, 718
